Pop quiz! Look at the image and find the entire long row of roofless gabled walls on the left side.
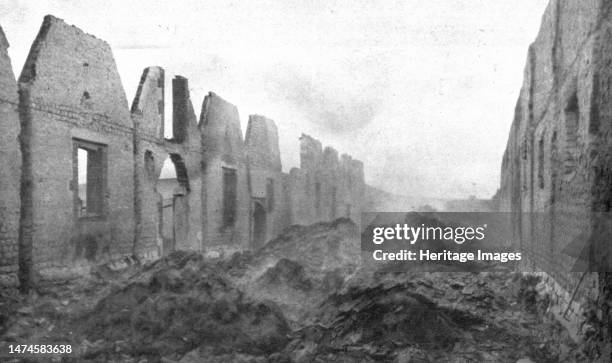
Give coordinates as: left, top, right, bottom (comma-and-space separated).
0, 16, 365, 284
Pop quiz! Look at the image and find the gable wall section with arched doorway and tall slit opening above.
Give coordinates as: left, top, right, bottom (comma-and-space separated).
132, 67, 202, 259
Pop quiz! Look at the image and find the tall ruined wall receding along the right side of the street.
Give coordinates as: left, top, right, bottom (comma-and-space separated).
499, 0, 612, 336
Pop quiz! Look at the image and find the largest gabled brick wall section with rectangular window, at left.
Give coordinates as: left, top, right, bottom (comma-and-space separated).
19, 16, 134, 274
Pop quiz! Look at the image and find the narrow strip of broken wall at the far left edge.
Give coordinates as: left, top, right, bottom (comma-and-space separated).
0, 27, 21, 285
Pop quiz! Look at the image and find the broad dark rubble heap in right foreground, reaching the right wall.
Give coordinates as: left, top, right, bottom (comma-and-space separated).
287, 271, 581, 362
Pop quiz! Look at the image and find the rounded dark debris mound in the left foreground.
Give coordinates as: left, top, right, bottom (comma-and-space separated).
78, 252, 289, 361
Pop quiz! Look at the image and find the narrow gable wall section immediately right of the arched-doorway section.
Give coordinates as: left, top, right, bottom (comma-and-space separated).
200, 92, 250, 252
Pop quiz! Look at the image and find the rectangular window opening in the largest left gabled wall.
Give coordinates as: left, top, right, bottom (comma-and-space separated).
74, 140, 106, 217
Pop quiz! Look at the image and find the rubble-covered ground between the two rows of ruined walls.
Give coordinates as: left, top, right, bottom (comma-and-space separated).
0, 219, 581, 363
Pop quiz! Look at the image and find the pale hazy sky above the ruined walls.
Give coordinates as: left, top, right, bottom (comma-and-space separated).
0, 0, 548, 198
